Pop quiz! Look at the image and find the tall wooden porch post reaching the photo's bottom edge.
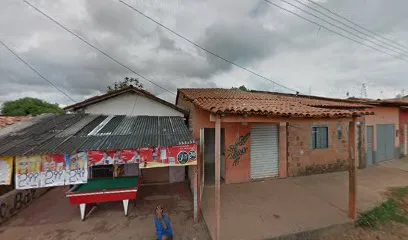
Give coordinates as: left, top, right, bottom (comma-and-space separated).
214, 115, 221, 240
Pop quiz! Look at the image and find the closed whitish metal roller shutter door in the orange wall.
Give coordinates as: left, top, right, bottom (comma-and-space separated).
251, 124, 279, 179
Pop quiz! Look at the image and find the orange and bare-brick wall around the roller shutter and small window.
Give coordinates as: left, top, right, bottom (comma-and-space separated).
177, 93, 350, 183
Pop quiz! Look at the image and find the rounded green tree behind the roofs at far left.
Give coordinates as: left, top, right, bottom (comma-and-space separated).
1, 97, 64, 116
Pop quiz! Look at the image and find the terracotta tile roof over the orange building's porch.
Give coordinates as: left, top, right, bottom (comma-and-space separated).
178, 88, 372, 117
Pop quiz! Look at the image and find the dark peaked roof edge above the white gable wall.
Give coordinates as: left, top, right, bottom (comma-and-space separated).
64, 85, 187, 115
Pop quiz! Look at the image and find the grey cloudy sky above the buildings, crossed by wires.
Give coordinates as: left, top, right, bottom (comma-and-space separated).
0, 0, 408, 105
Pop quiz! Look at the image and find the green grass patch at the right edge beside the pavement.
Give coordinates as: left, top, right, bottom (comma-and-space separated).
357, 187, 408, 228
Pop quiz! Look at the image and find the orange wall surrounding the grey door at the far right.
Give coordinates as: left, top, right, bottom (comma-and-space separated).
365, 107, 400, 151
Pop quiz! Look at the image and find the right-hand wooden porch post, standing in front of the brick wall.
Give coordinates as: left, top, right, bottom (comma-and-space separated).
348, 118, 358, 220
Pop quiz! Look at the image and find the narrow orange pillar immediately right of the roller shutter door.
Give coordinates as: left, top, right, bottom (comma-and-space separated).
279, 122, 288, 178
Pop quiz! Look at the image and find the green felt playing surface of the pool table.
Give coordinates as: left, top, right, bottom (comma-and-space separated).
74, 177, 139, 192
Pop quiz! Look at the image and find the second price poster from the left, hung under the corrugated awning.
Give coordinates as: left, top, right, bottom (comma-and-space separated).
15, 156, 41, 189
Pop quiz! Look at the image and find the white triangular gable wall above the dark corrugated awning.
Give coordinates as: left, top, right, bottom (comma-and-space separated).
84, 93, 184, 117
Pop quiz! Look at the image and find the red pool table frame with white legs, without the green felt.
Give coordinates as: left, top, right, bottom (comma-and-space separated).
66, 178, 142, 220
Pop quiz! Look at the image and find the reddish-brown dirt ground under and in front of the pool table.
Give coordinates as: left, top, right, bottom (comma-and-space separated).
0, 183, 209, 240
